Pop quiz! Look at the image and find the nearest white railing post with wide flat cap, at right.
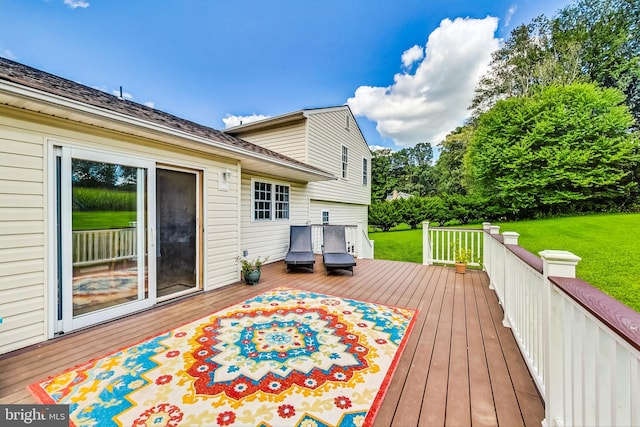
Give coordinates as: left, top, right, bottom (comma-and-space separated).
539, 250, 581, 427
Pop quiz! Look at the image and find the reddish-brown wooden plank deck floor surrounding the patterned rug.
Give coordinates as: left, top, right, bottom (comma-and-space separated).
0, 259, 544, 427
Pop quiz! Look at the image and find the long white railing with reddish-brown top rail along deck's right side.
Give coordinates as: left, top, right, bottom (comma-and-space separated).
424, 223, 640, 426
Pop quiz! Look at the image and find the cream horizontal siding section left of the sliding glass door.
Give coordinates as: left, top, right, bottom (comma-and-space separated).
0, 120, 46, 354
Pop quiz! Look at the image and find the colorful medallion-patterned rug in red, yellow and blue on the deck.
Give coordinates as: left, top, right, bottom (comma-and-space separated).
29, 288, 416, 427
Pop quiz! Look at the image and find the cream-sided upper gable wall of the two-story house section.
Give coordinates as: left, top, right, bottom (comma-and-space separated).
307, 108, 371, 207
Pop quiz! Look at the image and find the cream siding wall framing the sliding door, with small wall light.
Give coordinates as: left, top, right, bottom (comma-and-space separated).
0, 107, 240, 354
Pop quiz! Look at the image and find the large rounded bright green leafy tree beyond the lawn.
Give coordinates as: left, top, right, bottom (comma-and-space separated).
465, 84, 639, 217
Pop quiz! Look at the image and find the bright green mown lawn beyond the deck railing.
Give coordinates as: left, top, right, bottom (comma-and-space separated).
369, 214, 640, 312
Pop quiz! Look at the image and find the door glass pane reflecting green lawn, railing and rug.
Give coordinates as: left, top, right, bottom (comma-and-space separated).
71, 164, 140, 316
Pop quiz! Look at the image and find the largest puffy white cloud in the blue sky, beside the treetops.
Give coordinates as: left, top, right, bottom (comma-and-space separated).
347, 17, 499, 147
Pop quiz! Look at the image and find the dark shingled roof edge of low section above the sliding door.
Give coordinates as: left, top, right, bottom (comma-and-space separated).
0, 57, 331, 181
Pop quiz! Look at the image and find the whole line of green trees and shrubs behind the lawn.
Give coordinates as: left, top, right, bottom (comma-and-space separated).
369, 0, 640, 229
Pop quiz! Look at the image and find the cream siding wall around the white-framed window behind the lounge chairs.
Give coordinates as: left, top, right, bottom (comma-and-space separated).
240, 173, 309, 262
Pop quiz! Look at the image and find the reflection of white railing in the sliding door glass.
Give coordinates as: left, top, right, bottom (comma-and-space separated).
73, 228, 136, 267
